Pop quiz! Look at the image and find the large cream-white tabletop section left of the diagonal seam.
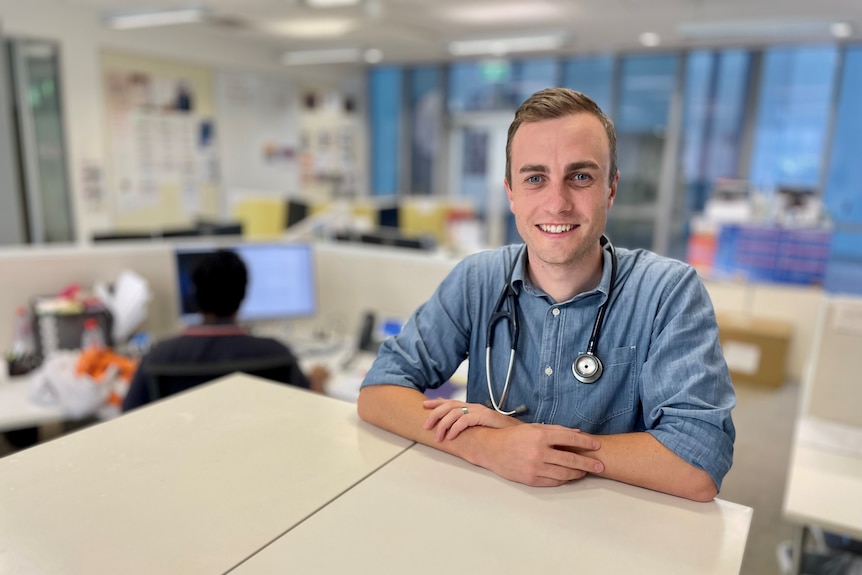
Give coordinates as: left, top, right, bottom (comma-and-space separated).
0, 375, 411, 575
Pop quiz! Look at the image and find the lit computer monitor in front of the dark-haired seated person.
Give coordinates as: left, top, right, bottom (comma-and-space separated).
175, 243, 317, 324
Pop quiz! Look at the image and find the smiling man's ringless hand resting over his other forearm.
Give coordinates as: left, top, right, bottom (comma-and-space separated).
473, 423, 604, 487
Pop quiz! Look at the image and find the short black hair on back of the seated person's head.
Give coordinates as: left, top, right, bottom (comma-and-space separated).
192, 250, 248, 318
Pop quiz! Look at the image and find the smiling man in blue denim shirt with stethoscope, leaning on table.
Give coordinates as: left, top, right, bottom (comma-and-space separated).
358, 88, 735, 501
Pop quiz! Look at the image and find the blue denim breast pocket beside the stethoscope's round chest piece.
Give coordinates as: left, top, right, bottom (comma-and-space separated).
575, 346, 637, 425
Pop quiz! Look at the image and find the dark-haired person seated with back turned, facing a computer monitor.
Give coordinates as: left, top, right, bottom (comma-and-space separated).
123, 250, 329, 411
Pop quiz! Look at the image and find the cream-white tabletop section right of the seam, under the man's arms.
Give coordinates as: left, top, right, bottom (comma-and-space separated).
231, 445, 752, 575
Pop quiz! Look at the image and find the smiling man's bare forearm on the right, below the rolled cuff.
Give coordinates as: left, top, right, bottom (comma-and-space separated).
584, 432, 718, 501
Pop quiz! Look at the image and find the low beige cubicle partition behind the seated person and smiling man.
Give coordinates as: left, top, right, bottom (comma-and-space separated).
0, 242, 836, 390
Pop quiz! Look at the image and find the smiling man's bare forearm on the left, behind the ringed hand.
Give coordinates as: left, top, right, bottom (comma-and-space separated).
357, 385, 489, 463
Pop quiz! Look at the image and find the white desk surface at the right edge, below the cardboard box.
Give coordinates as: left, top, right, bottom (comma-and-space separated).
784, 444, 862, 539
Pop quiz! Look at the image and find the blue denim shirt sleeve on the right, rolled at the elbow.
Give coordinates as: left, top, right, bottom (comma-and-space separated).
640, 267, 736, 489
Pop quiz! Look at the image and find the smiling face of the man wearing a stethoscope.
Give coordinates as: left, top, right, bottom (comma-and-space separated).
506, 113, 619, 267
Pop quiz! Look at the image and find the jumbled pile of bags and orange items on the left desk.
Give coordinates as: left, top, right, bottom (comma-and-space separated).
6, 271, 150, 419
